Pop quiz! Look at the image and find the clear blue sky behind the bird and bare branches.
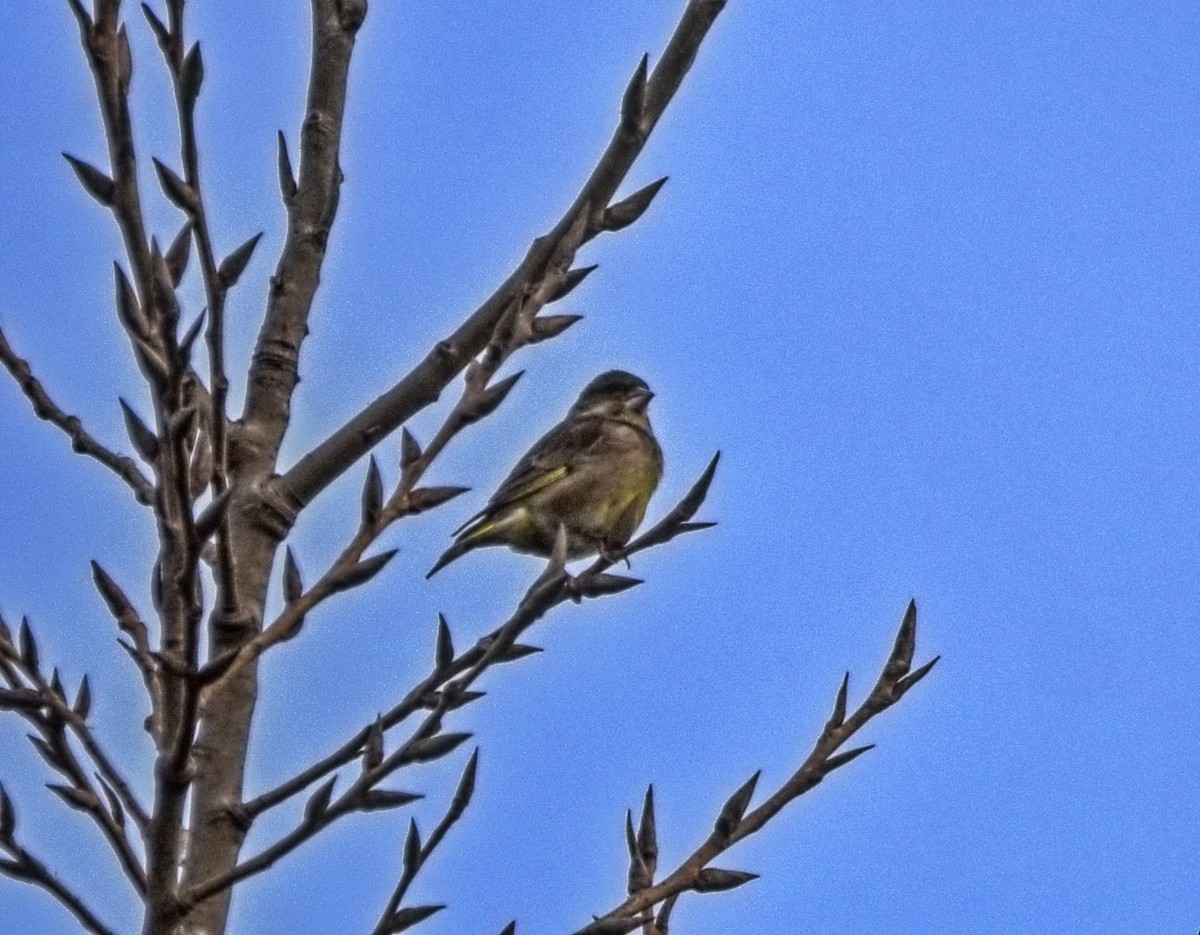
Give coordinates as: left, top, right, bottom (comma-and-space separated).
0, 0, 1200, 935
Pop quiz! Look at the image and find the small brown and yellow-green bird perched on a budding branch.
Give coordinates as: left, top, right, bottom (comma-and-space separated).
425, 370, 662, 579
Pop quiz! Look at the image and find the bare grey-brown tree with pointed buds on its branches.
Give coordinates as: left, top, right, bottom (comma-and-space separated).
0, 0, 936, 935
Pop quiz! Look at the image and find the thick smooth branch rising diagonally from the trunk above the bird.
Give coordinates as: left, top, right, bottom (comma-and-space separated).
277, 0, 725, 509
